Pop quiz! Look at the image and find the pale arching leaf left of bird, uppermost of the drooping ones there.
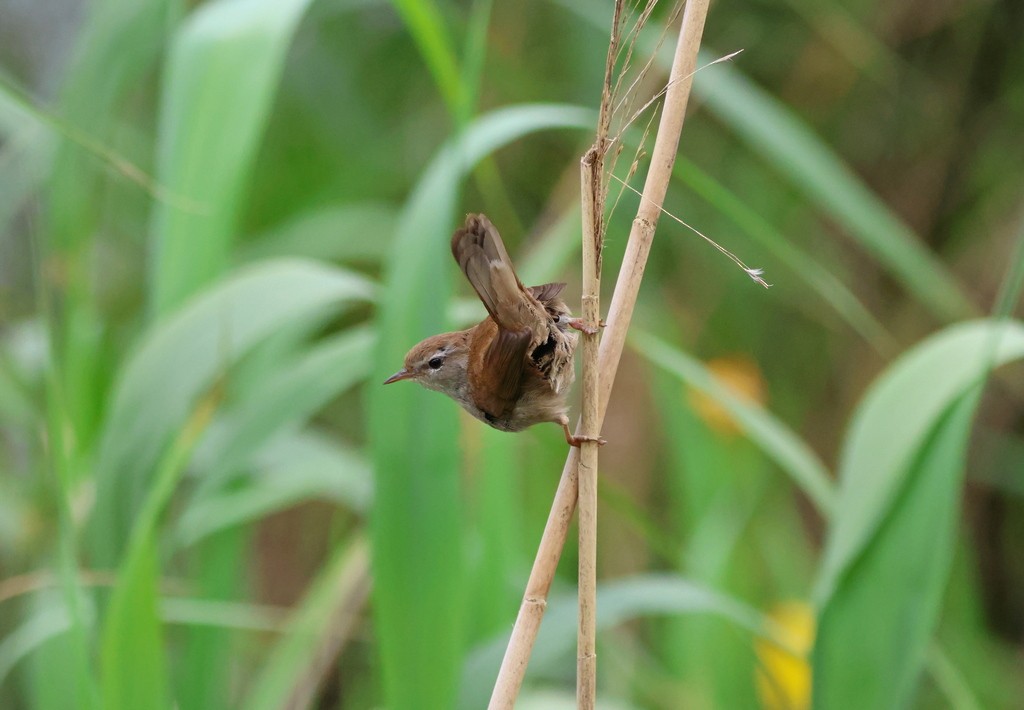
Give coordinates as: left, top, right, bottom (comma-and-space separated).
92, 260, 373, 566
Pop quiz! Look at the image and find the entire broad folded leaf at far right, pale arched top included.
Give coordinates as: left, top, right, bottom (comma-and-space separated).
813, 320, 1024, 708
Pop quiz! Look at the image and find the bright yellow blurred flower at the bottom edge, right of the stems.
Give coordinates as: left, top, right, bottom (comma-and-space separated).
755, 601, 814, 710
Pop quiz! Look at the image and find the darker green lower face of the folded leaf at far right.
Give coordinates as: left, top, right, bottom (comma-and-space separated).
813, 389, 979, 708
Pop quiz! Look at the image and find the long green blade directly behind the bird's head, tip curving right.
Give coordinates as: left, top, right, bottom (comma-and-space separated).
370, 100, 593, 708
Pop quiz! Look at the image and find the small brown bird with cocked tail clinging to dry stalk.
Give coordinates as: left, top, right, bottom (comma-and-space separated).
384, 214, 603, 447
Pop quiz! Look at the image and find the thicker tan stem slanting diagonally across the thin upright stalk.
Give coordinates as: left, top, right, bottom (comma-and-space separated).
487, 0, 710, 710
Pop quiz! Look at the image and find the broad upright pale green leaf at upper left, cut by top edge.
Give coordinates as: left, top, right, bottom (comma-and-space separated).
152, 0, 317, 314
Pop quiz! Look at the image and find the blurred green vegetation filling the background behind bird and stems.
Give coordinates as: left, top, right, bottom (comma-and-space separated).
0, 0, 1024, 709
